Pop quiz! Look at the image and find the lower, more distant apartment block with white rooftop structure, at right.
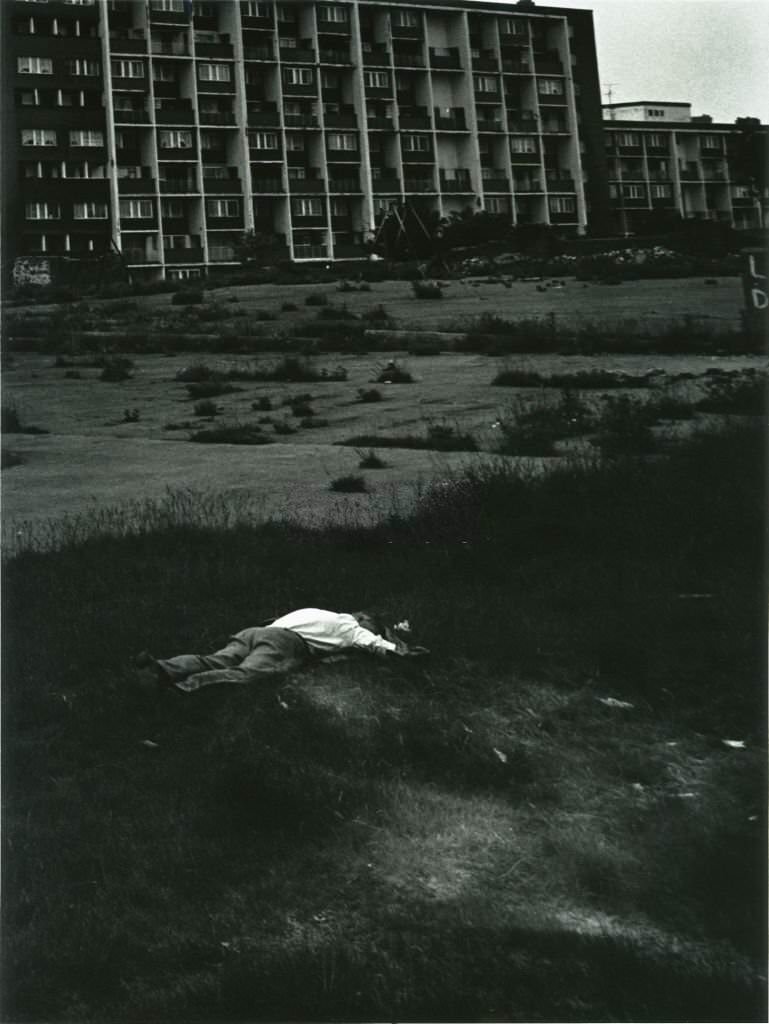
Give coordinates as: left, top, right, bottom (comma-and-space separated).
604, 101, 769, 232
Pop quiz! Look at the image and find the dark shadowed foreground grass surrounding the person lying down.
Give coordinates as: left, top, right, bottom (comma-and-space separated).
2, 421, 766, 1021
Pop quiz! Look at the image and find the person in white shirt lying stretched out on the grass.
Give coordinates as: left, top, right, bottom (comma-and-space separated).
136, 608, 429, 693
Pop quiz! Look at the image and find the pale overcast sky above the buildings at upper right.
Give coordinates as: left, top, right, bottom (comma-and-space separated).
493, 0, 769, 124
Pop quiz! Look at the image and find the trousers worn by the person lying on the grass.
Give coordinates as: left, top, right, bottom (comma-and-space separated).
158, 626, 310, 693
